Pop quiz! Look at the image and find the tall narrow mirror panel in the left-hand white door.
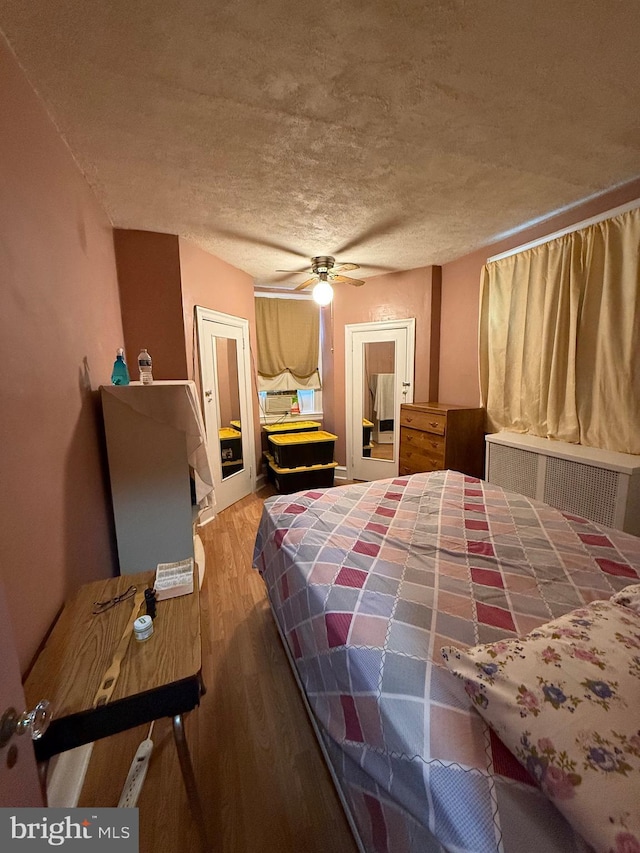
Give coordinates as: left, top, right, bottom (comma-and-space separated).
216, 338, 243, 480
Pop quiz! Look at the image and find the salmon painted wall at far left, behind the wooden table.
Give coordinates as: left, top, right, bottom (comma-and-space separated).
0, 36, 123, 672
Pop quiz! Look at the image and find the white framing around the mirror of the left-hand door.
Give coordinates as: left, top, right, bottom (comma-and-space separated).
195, 305, 256, 511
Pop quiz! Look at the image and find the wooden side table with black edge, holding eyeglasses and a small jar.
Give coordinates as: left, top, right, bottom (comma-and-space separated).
24, 571, 209, 850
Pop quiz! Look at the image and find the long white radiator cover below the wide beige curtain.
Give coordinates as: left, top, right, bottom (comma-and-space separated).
486, 432, 640, 536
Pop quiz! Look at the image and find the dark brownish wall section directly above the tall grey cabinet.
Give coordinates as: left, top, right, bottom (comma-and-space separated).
113, 228, 188, 380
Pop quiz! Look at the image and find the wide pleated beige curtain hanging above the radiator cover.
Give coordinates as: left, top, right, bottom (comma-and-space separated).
480, 209, 640, 454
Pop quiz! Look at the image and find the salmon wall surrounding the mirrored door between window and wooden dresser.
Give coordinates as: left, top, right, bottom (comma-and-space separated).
322, 267, 438, 465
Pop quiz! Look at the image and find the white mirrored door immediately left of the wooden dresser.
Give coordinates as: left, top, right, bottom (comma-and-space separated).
345, 318, 415, 480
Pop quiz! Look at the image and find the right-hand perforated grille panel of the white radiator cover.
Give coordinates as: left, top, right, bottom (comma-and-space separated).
542, 457, 619, 527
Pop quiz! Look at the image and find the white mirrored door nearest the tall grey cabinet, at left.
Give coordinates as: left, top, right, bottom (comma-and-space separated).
196, 306, 256, 512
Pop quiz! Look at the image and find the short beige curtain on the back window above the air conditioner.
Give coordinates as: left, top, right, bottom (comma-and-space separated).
256, 298, 320, 390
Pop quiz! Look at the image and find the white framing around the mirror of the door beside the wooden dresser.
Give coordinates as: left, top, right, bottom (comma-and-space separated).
344, 317, 416, 480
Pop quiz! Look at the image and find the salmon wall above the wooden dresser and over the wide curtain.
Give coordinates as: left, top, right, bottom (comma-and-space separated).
439, 180, 640, 406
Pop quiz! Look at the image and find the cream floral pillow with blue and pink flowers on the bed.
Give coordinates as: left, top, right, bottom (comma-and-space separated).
442, 591, 640, 853
